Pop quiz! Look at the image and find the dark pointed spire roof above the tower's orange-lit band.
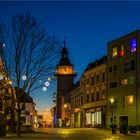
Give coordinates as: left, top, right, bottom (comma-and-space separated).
58, 41, 72, 66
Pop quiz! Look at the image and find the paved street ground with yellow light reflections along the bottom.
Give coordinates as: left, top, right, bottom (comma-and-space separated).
0, 128, 140, 140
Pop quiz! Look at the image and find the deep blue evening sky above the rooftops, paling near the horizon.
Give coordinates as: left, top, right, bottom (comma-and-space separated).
0, 1, 140, 110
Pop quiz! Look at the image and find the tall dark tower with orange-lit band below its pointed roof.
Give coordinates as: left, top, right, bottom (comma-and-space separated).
55, 41, 77, 124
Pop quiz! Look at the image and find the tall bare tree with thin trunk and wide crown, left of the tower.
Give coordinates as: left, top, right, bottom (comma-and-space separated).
1, 11, 60, 137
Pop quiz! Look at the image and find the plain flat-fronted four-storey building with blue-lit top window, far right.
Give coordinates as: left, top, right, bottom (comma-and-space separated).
107, 30, 140, 127
